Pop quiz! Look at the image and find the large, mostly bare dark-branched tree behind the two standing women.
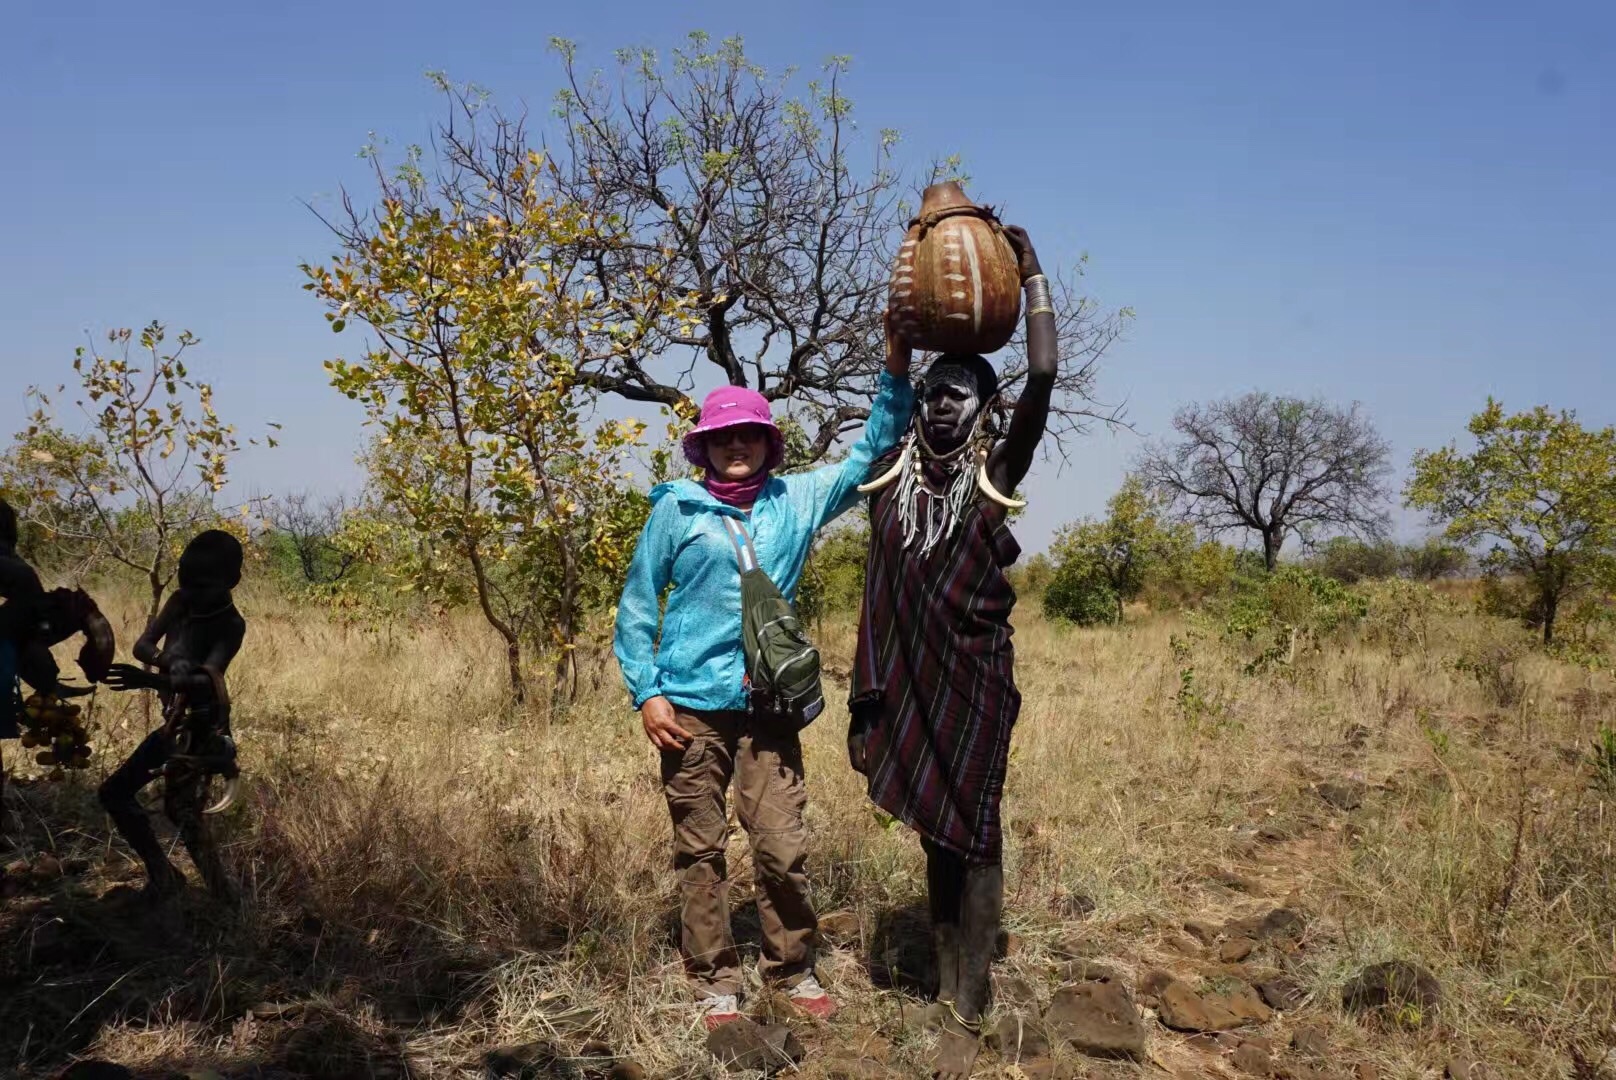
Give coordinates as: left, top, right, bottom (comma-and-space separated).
339, 34, 1126, 459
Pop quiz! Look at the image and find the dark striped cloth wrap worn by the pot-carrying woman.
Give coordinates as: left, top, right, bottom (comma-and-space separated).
850, 466, 1021, 863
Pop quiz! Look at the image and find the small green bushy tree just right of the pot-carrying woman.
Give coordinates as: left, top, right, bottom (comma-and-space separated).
1044, 475, 1194, 624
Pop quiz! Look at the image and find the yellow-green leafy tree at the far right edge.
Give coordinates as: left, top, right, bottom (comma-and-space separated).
1403, 398, 1616, 643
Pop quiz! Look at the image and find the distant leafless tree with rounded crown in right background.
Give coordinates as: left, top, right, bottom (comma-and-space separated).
1138, 393, 1390, 571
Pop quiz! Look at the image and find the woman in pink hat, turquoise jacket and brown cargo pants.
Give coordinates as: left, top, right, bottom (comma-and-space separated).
614, 330, 913, 1027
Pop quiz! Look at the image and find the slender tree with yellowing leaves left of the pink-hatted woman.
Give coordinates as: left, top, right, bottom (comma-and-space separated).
304, 152, 680, 700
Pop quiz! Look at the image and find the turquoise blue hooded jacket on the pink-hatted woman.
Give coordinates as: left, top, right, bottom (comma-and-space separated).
612, 372, 915, 711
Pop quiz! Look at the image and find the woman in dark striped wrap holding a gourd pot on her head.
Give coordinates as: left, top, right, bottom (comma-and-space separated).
847, 226, 1057, 1080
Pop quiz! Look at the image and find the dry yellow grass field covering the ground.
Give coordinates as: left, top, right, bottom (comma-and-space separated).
0, 585, 1616, 1080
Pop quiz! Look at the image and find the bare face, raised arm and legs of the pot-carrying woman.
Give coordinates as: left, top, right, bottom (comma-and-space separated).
847, 225, 1057, 1080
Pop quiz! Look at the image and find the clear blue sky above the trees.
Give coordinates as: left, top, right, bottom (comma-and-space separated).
0, 0, 1616, 550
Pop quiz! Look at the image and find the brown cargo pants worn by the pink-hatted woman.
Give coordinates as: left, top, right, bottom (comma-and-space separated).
663, 710, 819, 998
